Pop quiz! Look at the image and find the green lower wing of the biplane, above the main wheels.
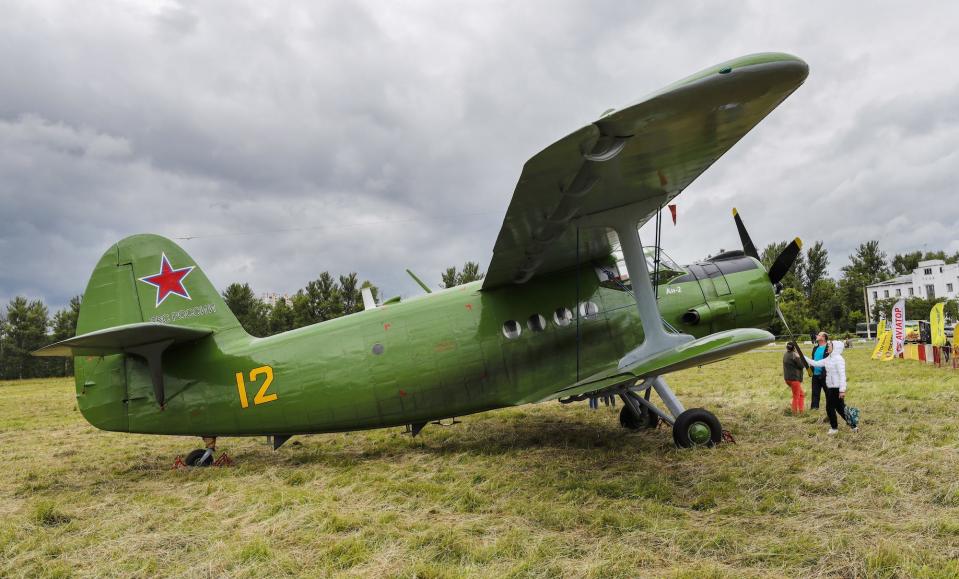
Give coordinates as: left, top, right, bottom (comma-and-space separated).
531, 328, 776, 402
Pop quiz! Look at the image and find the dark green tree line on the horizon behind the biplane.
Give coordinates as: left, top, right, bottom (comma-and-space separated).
0, 240, 959, 379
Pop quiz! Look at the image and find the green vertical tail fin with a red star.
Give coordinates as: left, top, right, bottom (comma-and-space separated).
77, 235, 240, 335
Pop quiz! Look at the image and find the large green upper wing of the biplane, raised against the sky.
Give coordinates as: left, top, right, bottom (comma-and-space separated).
483, 53, 809, 289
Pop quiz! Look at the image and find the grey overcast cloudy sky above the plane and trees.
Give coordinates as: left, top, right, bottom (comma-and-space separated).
0, 0, 959, 307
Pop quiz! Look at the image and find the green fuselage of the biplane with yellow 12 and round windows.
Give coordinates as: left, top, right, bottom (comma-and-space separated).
76, 257, 775, 436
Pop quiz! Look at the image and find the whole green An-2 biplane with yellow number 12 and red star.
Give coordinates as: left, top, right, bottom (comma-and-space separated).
36, 53, 808, 466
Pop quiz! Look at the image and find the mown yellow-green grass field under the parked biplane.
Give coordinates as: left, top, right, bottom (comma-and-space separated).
0, 349, 959, 577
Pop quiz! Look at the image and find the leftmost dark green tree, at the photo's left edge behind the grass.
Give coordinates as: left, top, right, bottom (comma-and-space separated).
4, 296, 49, 379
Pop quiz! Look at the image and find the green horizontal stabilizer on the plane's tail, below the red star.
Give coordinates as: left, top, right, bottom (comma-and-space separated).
32, 322, 213, 356
